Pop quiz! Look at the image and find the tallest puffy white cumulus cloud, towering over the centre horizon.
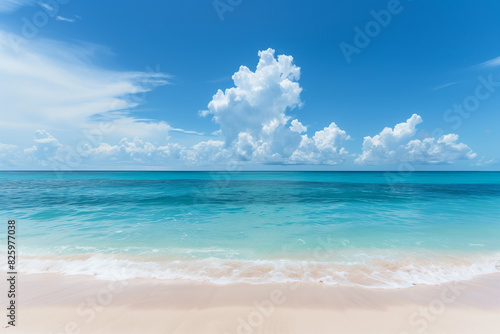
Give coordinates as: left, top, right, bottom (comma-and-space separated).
201, 49, 349, 164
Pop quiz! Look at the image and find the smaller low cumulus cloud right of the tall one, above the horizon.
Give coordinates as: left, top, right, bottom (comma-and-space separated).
355, 114, 476, 165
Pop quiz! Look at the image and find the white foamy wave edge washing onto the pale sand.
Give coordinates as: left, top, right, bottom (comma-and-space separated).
6, 253, 500, 289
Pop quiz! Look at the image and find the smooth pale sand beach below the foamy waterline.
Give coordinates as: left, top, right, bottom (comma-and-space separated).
5, 274, 500, 334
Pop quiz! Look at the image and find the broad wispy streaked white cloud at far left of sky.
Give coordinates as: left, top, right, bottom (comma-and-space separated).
0, 31, 174, 147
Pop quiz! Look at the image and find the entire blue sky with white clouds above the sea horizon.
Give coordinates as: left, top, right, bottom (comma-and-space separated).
0, 0, 500, 170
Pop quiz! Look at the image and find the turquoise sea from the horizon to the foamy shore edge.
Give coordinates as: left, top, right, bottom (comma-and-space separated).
0, 172, 500, 287
